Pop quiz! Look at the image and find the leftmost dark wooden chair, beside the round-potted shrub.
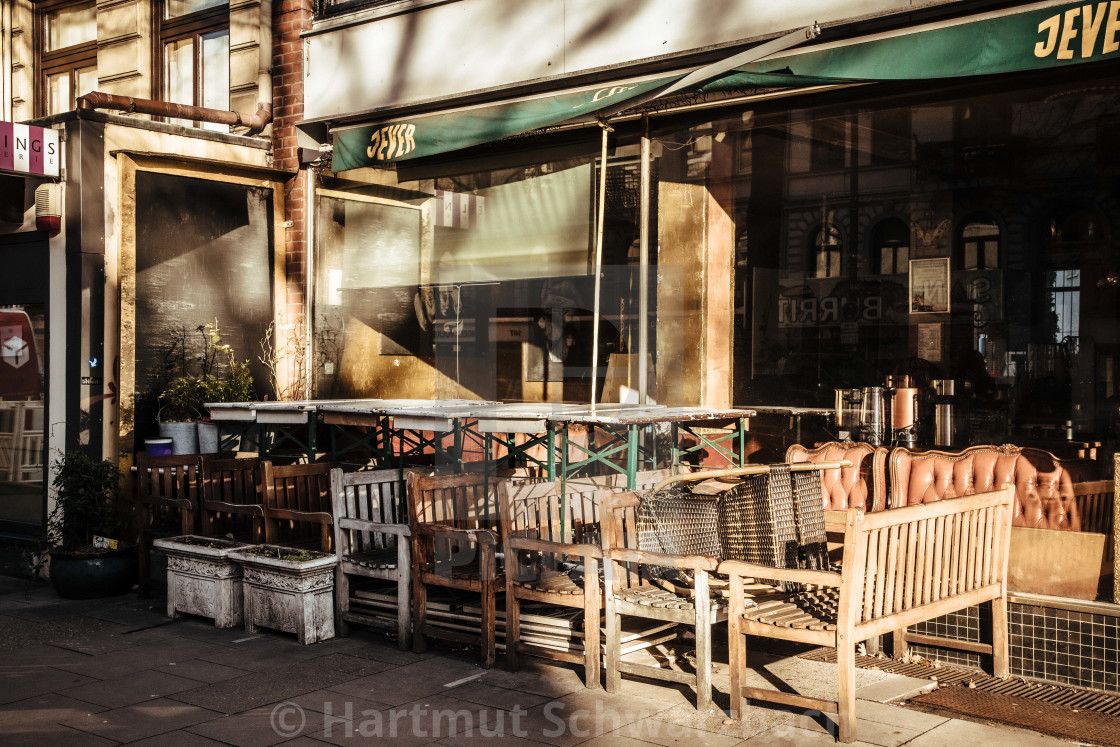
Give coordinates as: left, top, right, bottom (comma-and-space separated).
136, 451, 200, 597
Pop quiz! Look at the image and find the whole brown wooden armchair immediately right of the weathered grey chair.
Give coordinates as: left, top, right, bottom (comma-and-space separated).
408, 473, 505, 669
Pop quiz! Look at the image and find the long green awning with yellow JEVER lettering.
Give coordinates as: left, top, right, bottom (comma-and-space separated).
332, 2, 1120, 171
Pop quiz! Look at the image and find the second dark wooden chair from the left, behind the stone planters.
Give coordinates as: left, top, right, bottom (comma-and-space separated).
199, 454, 264, 544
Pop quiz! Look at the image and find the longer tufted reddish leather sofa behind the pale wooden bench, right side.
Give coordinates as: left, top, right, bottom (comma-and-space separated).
888, 445, 1081, 532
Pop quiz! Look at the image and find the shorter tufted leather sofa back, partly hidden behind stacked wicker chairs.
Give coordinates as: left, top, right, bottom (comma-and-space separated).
785, 441, 887, 512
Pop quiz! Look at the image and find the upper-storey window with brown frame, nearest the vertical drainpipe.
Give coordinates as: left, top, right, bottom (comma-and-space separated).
160, 0, 230, 131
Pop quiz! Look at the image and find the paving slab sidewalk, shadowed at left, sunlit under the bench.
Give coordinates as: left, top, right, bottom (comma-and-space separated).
0, 577, 1084, 747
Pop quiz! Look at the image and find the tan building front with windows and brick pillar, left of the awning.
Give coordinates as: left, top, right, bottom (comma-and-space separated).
0, 0, 310, 536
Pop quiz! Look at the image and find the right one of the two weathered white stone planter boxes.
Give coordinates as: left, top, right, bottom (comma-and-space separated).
231, 544, 338, 644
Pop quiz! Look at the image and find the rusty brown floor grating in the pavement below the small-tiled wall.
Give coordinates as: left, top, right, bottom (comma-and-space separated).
801, 648, 1120, 747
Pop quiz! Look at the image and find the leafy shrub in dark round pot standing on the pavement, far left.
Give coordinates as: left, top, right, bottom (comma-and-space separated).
45, 451, 137, 599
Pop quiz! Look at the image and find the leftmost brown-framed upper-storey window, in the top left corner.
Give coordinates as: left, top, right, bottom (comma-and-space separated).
38, 0, 97, 115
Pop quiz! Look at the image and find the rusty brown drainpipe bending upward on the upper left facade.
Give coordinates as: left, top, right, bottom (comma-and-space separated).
77, 0, 272, 134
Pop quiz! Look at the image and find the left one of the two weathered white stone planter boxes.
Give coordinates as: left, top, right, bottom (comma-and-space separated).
152, 534, 250, 627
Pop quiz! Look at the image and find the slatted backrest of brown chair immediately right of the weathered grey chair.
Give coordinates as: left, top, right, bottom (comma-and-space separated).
407, 473, 502, 532
